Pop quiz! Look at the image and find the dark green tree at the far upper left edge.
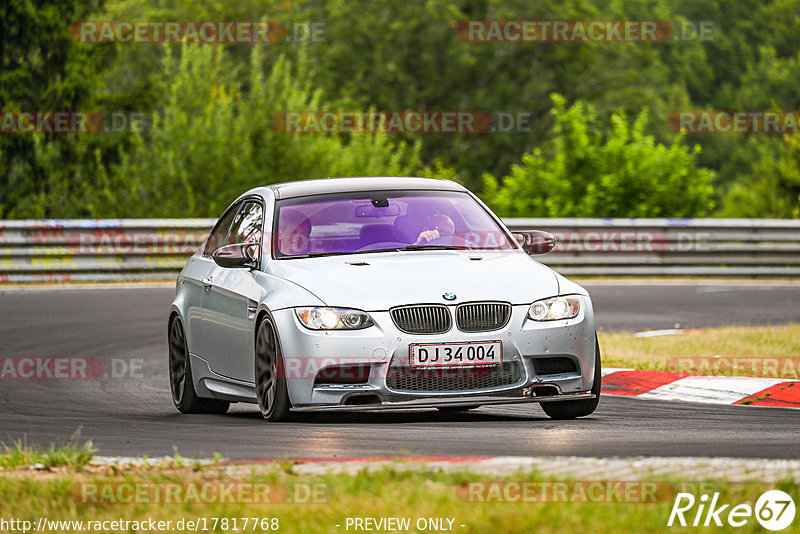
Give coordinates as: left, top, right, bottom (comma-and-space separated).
0, 0, 109, 218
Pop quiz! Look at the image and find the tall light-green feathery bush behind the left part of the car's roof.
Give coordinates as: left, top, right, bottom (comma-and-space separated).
97, 45, 421, 217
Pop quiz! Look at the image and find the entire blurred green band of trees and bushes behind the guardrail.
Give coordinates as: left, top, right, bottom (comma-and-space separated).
0, 0, 800, 219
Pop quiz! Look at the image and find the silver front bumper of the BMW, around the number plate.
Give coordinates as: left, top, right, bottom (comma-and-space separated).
273, 296, 595, 411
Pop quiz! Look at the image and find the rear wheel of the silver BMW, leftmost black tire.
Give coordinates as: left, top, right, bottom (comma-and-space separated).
167, 316, 231, 414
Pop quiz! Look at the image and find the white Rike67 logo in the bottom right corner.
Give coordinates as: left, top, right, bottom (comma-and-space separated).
667, 490, 795, 531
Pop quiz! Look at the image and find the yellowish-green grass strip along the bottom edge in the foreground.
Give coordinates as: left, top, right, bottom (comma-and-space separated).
0, 466, 800, 534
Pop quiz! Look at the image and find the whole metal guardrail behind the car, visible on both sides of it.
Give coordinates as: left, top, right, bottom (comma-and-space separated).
0, 219, 800, 283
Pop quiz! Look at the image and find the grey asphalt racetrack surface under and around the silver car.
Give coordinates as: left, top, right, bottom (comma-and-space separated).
0, 282, 800, 458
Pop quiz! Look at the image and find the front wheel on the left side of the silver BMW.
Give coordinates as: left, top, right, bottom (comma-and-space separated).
255, 317, 292, 422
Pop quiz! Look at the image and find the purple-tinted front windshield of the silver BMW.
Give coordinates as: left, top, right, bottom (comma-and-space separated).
273, 191, 515, 258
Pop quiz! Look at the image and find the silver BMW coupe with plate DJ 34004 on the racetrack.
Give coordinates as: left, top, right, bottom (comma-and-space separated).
167, 177, 601, 421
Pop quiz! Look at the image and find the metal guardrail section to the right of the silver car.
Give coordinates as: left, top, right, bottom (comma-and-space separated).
505, 219, 800, 278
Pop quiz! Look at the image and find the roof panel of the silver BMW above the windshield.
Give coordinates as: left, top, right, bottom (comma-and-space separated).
267, 176, 466, 199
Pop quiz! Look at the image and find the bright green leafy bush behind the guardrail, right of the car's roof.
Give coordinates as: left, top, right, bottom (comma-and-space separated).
484, 95, 714, 217
